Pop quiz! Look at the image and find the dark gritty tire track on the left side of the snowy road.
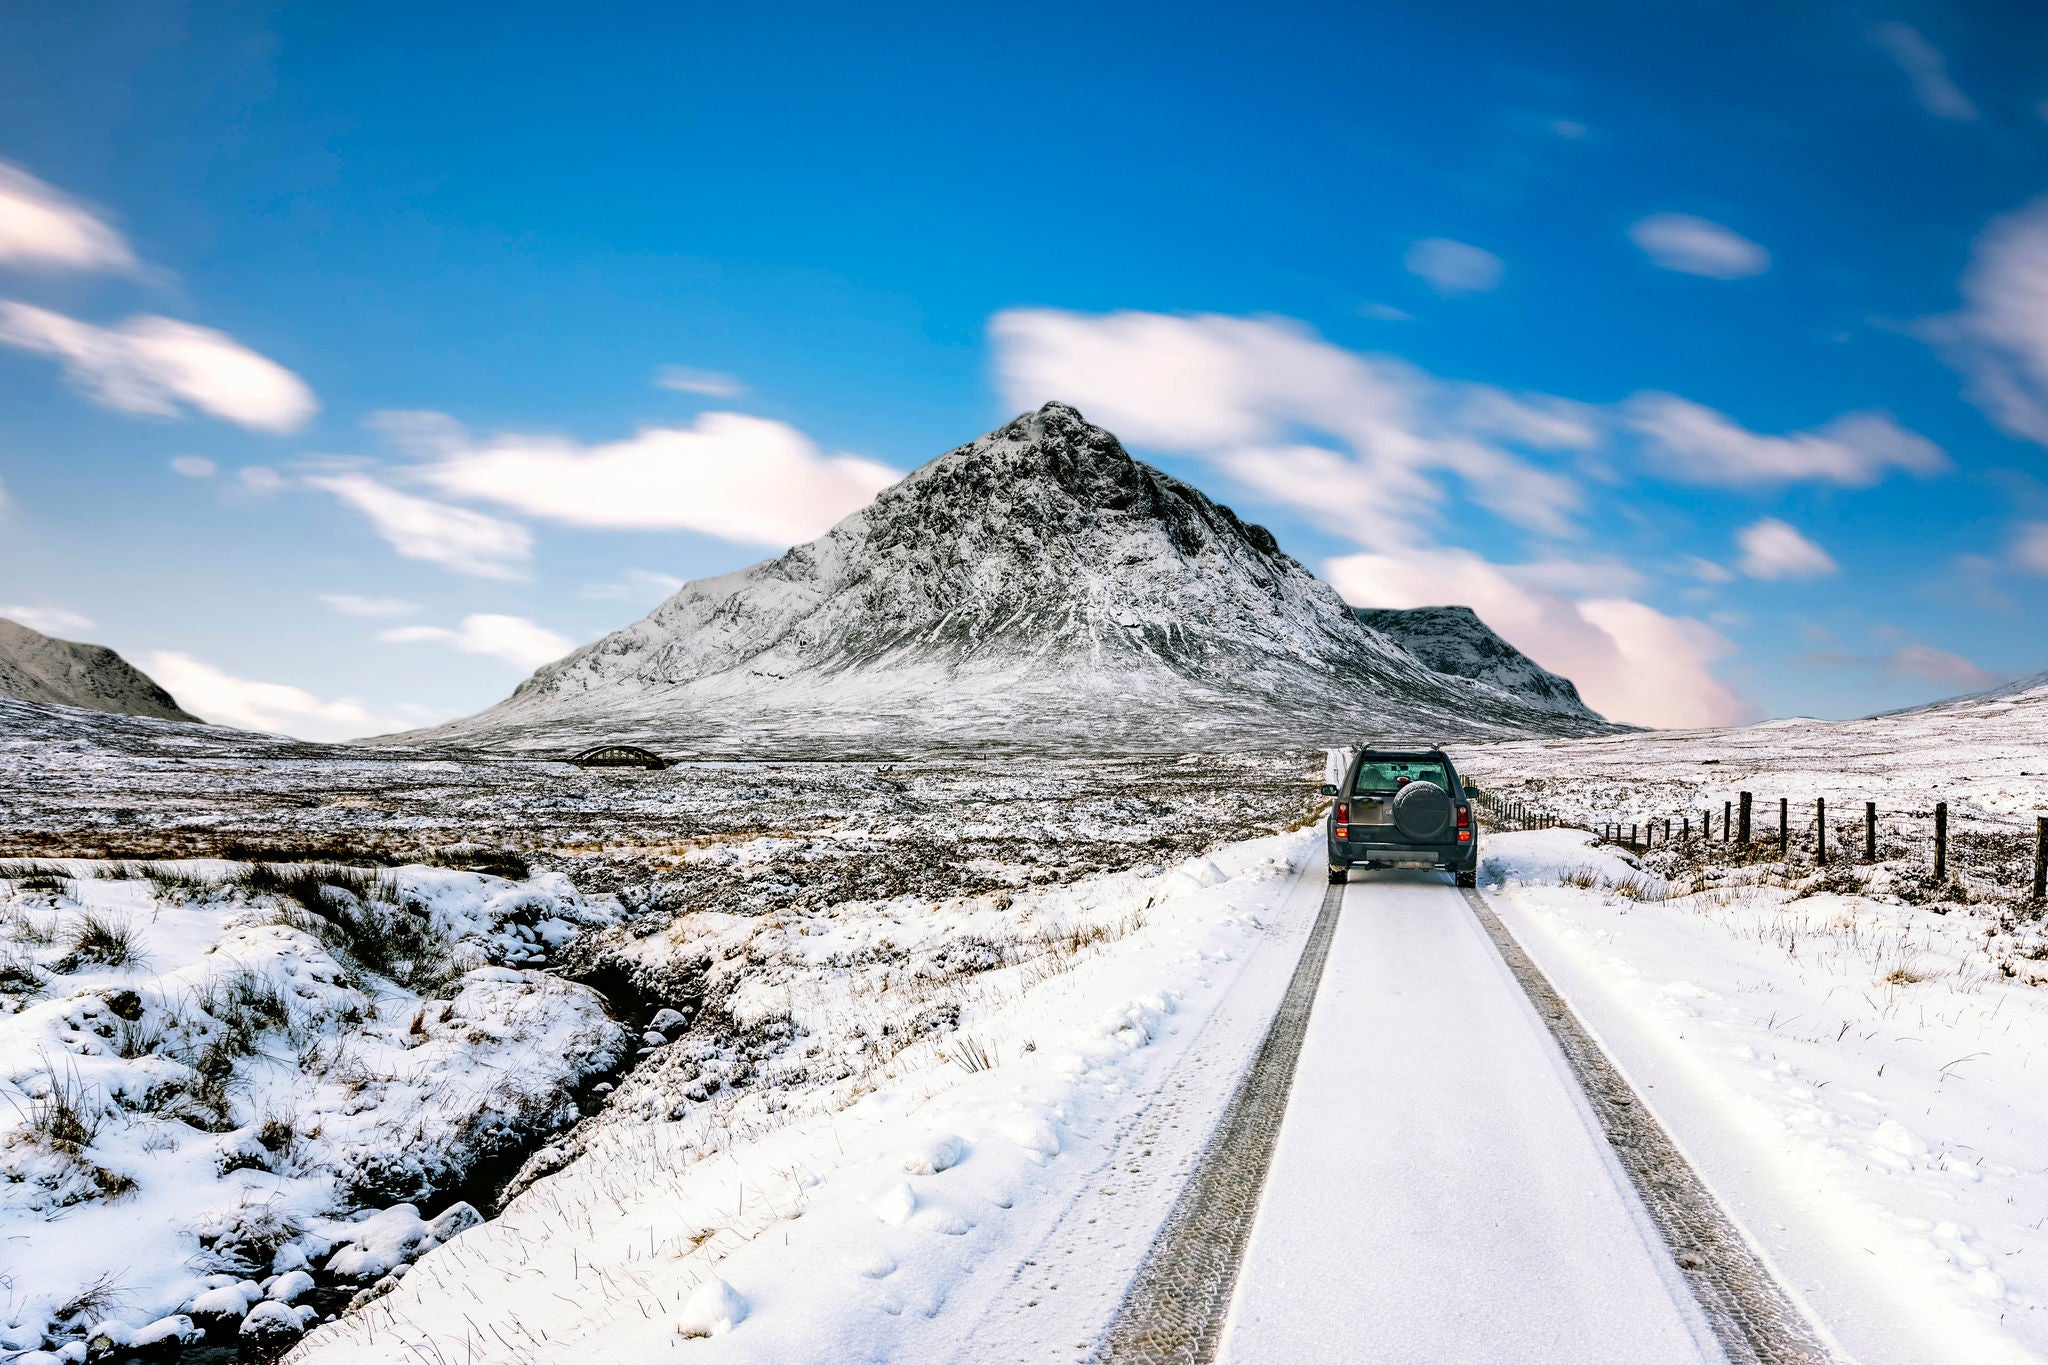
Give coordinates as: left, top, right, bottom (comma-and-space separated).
1096, 884, 1343, 1365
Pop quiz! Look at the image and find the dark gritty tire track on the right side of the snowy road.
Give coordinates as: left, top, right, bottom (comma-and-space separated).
1462, 888, 1837, 1365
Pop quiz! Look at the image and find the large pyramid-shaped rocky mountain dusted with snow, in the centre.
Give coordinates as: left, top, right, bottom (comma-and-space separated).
403, 403, 1610, 753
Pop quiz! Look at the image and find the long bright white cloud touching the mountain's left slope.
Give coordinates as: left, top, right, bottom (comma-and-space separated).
408, 411, 903, 546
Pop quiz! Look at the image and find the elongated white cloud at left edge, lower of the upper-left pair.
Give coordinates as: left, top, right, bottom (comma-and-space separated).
0, 301, 319, 432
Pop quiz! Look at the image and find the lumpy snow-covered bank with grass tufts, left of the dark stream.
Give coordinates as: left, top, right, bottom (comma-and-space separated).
0, 862, 627, 1351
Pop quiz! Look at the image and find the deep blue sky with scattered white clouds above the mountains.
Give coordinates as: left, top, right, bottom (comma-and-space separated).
0, 0, 2048, 737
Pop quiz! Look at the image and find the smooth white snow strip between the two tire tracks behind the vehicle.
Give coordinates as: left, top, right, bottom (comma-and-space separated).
1221, 872, 1722, 1365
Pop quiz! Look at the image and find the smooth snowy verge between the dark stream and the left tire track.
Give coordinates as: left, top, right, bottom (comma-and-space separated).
295, 829, 1321, 1365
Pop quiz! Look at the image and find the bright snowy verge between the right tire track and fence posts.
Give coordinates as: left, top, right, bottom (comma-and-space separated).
1483, 829, 2048, 1365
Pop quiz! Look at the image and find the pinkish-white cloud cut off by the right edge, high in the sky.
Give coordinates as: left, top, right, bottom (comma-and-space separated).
1925, 196, 2048, 446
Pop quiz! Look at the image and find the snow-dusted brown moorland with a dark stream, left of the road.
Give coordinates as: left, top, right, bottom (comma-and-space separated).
0, 702, 1313, 1359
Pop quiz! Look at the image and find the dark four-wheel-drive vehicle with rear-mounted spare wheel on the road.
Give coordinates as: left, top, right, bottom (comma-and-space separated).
1323, 749, 1479, 886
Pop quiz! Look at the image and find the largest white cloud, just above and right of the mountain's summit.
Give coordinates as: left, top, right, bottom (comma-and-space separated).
989, 309, 1599, 546
